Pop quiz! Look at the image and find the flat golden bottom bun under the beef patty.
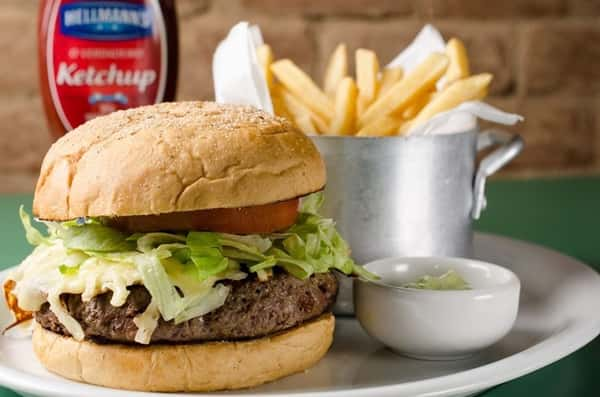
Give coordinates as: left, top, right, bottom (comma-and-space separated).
33, 313, 335, 392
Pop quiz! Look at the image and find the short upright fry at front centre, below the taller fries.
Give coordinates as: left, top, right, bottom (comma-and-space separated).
328, 77, 358, 135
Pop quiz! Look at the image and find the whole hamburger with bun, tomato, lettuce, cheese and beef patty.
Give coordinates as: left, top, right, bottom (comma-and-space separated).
4, 102, 369, 391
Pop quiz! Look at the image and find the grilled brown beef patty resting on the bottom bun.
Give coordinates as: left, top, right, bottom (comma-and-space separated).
35, 271, 338, 343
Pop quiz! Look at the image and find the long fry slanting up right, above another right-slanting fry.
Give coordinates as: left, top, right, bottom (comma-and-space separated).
358, 53, 448, 128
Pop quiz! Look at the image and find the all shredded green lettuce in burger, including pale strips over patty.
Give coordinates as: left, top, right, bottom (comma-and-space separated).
19, 193, 375, 341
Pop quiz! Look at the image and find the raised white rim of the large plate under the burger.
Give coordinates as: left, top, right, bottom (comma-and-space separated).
0, 232, 600, 397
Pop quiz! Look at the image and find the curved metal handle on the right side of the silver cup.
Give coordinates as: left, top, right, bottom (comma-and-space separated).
471, 128, 524, 219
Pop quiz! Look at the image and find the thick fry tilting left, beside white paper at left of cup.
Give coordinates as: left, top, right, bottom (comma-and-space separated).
271, 59, 334, 122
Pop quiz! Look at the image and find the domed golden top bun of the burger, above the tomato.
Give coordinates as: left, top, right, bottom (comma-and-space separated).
33, 102, 325, 220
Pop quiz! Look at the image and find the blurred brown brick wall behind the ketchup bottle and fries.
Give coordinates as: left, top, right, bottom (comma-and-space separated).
0, 0, 600, 192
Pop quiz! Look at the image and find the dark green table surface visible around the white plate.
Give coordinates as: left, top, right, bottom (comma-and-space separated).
0, 177, 600, 397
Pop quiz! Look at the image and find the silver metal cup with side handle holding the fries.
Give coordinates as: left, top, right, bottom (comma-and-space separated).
312, 129, 523, 314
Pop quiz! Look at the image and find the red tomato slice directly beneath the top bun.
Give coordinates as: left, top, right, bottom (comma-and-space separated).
109, 198, 299, 234
